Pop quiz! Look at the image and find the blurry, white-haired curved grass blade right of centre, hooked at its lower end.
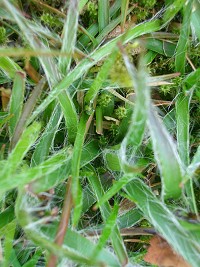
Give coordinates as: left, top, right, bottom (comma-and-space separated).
120, 54, 150, 169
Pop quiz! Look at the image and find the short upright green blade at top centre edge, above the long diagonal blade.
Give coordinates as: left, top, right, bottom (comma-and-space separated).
98, 0, 110, 32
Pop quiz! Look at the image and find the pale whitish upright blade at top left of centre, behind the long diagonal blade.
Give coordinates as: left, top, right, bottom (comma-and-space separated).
58, 0, 79, 75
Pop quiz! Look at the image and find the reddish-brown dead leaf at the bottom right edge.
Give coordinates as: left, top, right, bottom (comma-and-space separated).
144, 235, 191, 267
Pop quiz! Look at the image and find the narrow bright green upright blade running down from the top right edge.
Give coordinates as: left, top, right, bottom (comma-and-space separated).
175, 0, 193, 74
